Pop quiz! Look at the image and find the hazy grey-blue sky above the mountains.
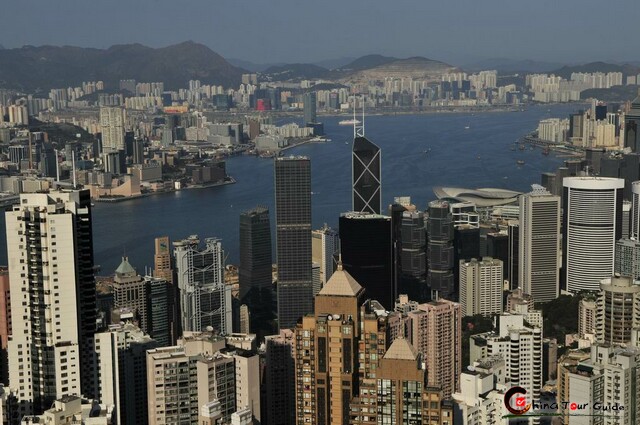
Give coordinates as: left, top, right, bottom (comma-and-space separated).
0, 0, 640, 64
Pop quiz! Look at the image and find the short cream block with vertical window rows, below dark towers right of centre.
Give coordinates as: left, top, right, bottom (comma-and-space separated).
460, 257, 504, 316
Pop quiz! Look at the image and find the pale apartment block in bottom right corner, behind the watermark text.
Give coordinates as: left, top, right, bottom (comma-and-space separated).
559, 344, 640, 425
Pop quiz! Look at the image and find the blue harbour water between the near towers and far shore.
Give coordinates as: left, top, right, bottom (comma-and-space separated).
0, 105, 579, 274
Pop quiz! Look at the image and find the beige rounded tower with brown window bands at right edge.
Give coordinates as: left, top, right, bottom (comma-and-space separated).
596, 276, 640, 344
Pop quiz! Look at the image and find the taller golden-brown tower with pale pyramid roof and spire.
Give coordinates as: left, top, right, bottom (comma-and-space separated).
295, 264, 386, 425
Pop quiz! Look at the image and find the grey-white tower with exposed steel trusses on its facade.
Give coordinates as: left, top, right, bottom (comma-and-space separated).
173, 236, 233, 335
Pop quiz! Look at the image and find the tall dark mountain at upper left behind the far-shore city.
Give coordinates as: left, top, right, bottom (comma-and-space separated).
0, 41, 246, 92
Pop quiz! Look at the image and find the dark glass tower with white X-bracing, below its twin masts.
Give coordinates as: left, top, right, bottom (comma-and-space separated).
352, 137, 382, 214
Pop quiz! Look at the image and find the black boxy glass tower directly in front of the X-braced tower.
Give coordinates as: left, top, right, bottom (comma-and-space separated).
339, 212, 398, 309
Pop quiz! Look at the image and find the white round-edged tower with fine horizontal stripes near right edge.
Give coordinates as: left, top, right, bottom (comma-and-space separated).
563, 177, 624, 292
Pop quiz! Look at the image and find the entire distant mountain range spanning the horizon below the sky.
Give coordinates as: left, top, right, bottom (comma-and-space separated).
0, 41, 640, 93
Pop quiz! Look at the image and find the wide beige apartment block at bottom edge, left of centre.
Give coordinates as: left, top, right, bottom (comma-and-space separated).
146, 332, 261, 425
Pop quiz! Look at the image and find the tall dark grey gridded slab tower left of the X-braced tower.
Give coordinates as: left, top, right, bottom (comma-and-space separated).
274, 156, 313, 329
